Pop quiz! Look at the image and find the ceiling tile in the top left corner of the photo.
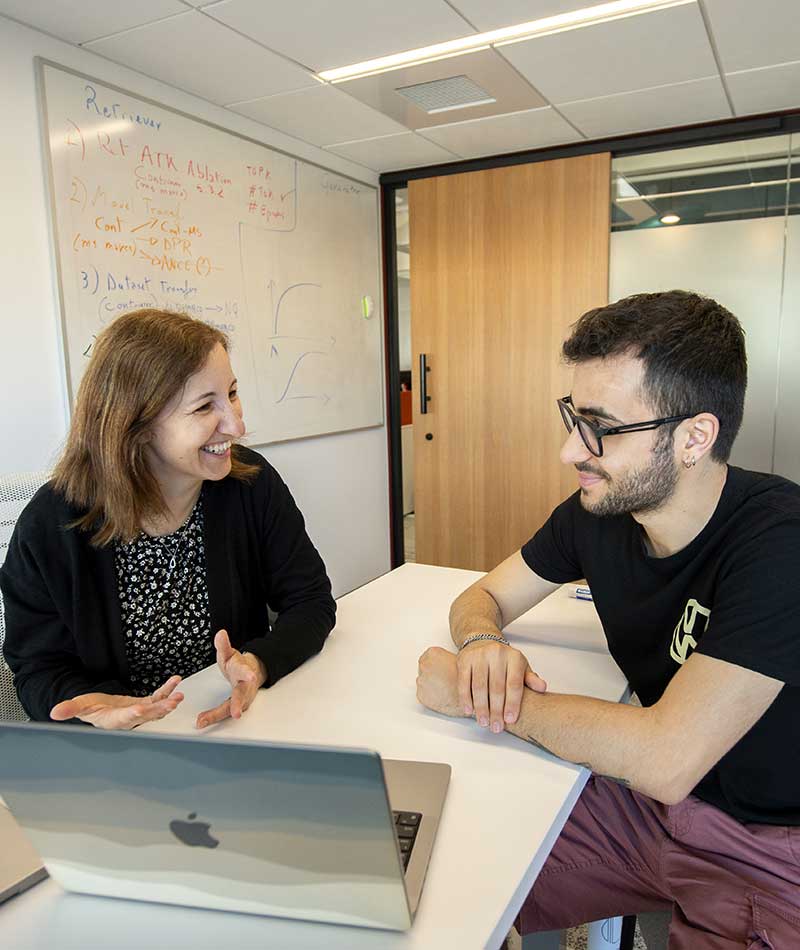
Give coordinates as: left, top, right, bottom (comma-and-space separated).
0, 0, 186, 43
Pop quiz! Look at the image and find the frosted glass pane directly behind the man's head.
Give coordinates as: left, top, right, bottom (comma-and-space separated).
609, 217, 788, 478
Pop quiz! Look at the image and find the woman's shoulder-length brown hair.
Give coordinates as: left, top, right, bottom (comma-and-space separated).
53, 310, 258, 547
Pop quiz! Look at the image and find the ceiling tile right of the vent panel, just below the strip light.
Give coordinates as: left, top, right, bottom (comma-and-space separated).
499, 4, 718, 104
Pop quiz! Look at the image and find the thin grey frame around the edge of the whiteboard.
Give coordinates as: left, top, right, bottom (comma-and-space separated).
33, 56, 386, 445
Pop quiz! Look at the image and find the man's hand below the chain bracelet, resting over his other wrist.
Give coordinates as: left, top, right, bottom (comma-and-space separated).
456, 640, 547, 732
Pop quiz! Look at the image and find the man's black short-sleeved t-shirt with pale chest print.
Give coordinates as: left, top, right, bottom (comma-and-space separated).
522, 467, 800, 825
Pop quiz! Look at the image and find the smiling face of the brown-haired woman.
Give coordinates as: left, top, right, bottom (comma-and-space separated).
147, 344, 245, 496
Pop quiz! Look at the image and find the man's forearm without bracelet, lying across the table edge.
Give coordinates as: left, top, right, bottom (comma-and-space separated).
506, 689, 684, 803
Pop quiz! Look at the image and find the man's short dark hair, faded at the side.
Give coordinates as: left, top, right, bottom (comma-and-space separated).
562, 290, 747, 462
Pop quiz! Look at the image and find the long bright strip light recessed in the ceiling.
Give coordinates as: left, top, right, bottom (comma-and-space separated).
317, 0, 695, 82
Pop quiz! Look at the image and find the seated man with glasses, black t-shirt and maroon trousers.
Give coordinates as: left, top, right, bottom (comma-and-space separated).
417, 291, 800, 950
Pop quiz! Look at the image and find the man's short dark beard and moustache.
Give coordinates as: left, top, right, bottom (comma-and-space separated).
575, 440, 678, 518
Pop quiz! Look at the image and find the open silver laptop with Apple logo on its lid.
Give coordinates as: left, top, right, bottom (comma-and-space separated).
0, 723, 450, 930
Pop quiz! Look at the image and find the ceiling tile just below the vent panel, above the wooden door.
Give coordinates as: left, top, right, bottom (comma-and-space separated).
420, 107, 581, 158
